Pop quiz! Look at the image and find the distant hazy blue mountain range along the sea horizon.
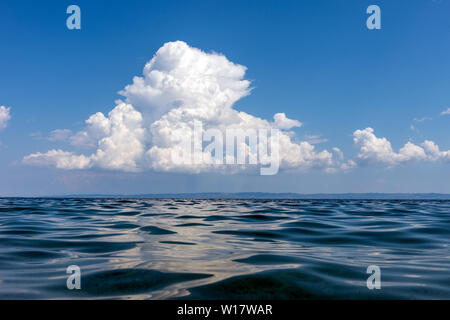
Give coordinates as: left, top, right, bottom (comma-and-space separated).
45, 192, 450, 200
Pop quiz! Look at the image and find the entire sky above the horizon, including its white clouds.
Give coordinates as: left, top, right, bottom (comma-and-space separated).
0, 0, 450, 196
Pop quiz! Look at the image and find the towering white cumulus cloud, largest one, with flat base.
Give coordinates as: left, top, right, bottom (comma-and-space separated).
23, 41, 342, 172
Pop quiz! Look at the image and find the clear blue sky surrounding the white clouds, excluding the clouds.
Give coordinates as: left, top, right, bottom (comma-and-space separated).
0, 0, 450, 196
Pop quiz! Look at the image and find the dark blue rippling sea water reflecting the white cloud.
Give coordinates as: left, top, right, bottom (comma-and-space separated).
0, 199, 450, 299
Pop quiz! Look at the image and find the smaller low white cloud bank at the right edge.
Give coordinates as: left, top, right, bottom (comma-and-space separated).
353, 128, 450, 166
